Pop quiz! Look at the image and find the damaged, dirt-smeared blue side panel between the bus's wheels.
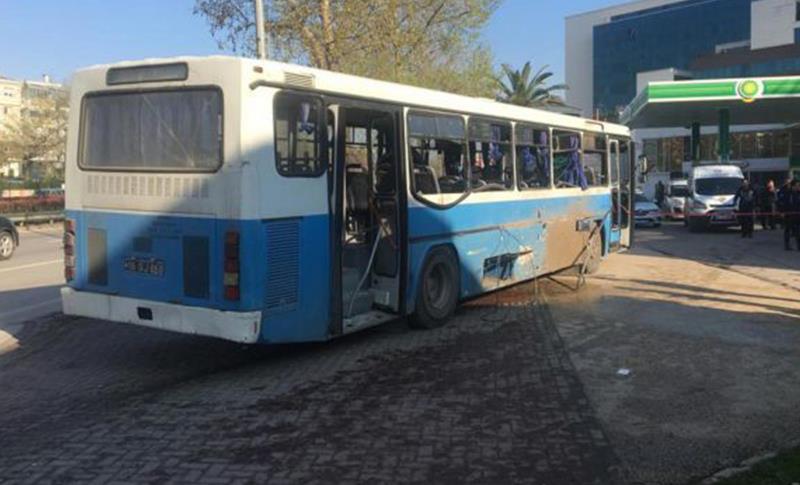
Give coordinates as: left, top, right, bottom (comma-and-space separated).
407, 194, 611, 313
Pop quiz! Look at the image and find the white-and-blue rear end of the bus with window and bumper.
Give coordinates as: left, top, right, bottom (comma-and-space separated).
62, 58, 261, 342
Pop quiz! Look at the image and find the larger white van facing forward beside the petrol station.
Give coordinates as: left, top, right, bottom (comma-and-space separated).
684, 165, 744, 231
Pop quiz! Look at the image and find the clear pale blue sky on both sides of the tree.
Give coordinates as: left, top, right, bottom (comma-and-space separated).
0, 0, 621, 82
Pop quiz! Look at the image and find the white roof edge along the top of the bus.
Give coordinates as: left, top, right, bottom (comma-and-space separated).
76, 56, 630, 137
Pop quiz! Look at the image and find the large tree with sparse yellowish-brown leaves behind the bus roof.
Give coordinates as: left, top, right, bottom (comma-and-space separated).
195, 0, 499, 96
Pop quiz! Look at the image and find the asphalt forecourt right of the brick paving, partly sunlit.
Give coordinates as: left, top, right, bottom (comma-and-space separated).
549, 224, 800, 484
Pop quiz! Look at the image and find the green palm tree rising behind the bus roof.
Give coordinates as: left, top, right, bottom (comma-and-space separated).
497, 62, 568, 107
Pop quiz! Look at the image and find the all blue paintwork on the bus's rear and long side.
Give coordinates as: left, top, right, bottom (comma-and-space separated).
67, 194, 610, 343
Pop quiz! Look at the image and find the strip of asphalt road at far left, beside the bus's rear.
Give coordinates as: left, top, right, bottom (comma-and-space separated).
0, 225, 64, 331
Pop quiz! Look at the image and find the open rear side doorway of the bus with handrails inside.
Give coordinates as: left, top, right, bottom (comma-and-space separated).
331, 102, 404, 334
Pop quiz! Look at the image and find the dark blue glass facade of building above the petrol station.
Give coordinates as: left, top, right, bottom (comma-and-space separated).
593, 0, 800, 115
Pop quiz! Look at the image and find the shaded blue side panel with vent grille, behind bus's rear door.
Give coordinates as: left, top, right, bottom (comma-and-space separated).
260, 214, 331, 343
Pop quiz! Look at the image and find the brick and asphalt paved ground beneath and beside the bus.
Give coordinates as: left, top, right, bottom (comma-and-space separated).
0, 225, 800, 485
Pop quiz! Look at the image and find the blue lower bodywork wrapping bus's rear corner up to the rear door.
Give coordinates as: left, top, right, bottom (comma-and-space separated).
67, 210, 330, 343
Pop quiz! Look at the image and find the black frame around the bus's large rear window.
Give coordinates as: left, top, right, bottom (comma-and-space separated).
77, 84, 226, 174
